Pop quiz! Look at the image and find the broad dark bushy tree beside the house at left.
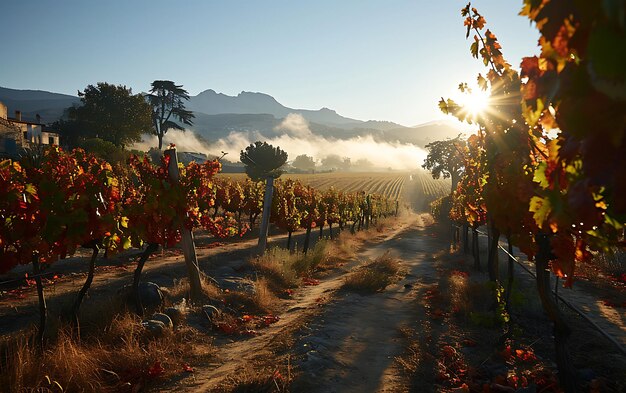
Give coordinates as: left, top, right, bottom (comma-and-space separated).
67, 82, 152, 148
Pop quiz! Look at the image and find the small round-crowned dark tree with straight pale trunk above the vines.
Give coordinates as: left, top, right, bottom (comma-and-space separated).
240, 141, 287, 255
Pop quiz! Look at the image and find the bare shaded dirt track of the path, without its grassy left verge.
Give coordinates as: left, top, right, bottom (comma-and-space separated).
292, 214, 446, 392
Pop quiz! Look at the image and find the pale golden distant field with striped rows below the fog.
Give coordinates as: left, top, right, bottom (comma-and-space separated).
218, 171, 450, 211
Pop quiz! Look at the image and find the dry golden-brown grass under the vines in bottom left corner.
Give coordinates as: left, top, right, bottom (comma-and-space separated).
0, 314, 210, 392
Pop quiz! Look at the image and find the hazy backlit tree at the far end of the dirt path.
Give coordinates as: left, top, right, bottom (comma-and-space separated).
422, 135, 466, 192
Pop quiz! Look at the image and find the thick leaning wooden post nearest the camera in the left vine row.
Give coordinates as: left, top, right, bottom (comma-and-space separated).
164, 147, 202, 301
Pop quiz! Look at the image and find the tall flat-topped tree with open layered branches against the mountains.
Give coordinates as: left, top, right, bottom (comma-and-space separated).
147, 81, 195, 150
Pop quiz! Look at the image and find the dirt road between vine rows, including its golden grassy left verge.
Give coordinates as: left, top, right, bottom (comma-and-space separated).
159, 216, 454, 392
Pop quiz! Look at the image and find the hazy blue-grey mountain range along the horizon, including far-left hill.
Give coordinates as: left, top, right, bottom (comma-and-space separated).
0, 87, 459, 146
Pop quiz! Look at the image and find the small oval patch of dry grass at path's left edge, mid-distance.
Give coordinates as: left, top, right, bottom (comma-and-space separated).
343, 252, 401, 293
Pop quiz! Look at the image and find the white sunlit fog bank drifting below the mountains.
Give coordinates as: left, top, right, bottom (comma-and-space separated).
134, 113, 427, 170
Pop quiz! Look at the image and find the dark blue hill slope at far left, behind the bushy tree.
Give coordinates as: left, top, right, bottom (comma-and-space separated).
0, 87, 80, 123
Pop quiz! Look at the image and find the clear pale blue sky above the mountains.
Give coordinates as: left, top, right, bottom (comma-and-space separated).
0, 0, 538, 125
